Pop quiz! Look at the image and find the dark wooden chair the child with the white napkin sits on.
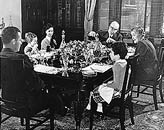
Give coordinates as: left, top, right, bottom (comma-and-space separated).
90, 55, 138, 130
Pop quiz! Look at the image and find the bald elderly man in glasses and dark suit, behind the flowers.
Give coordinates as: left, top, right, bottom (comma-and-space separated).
88, 21, 123, 46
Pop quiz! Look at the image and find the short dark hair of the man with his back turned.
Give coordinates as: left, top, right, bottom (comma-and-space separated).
2, 26, 20, 44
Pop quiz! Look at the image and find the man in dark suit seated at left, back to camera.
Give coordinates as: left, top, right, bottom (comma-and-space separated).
0, 27, 64, 115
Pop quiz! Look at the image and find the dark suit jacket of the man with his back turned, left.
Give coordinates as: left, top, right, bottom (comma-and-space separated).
0, 48, 48, 112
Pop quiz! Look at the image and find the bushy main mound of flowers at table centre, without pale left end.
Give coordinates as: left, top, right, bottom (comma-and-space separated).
59, 40, 109, 69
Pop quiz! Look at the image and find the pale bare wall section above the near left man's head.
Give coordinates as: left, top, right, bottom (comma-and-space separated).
0, 0, 22, 30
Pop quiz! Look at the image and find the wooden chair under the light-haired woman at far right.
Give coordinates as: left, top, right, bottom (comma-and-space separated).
134, 41, 164, 110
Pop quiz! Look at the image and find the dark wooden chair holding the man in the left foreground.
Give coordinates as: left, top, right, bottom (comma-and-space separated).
0, 57, 54, 130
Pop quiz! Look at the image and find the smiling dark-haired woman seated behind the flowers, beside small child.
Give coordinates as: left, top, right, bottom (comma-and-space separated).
41, 23, 57, 51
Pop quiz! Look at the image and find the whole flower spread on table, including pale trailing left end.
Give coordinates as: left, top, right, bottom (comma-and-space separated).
30, 40, 109, 70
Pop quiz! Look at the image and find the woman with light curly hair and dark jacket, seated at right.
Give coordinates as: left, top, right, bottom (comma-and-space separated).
131, 27, 158, 84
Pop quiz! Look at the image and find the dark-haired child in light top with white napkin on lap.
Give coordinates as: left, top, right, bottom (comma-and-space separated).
87, 42, 127, 112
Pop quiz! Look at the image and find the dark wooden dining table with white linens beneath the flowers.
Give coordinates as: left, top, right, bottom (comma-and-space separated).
34, 63, 113, 130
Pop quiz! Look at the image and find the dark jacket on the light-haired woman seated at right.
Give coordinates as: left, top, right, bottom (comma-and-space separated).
135, 40, 158, 83
